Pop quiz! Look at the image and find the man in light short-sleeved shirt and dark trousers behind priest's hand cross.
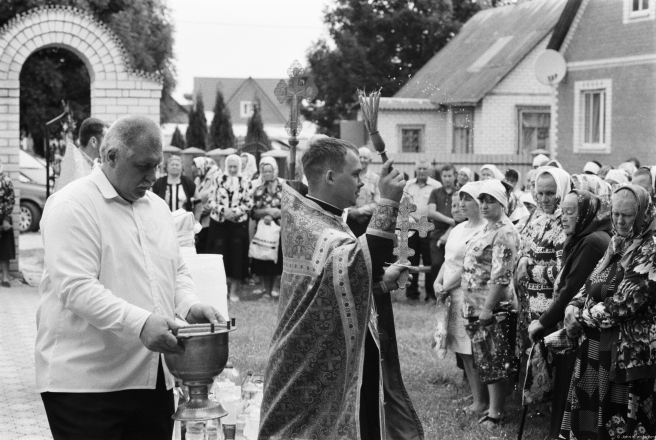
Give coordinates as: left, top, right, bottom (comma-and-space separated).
405, 159, 442, 301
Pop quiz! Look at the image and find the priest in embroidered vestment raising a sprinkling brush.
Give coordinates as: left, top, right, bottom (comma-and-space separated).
259, 137, 423, 440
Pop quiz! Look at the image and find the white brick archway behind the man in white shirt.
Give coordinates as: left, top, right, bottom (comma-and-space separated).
0, 6, 162, 269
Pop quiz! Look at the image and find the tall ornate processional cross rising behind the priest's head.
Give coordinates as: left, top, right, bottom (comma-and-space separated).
274, 60, 319, 180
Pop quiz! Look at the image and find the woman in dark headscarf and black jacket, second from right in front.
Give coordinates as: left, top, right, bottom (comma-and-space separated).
528, 190, 611, 439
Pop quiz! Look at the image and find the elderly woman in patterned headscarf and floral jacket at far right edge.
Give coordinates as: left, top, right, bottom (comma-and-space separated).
561, 184, 656, 440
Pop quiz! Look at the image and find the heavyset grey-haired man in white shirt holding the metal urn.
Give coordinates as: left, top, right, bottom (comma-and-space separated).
35, 116, 223, 440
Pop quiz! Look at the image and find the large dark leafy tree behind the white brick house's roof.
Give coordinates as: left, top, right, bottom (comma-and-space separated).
303, 0, 499, 136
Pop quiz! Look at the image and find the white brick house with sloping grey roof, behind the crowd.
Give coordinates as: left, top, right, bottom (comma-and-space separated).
352, 0, 567, 177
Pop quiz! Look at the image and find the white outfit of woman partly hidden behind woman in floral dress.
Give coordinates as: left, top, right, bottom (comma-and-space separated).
443, 223, 485, 354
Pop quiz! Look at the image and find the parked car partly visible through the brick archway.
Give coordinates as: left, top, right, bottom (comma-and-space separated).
14, 150, 46, 232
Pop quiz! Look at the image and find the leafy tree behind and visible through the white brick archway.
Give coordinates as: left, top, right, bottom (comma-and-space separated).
0, 0, 175, 150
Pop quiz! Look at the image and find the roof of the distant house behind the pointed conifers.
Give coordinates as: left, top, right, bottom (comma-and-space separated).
194, 77, 289, 120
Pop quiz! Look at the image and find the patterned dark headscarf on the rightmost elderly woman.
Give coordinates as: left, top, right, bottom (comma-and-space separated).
602, 184, 656, 270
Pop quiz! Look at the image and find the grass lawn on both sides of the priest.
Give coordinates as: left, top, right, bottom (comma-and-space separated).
230, 297, 549, 440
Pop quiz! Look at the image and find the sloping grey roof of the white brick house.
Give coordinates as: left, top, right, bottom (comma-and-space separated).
394, 0, 567, 105
